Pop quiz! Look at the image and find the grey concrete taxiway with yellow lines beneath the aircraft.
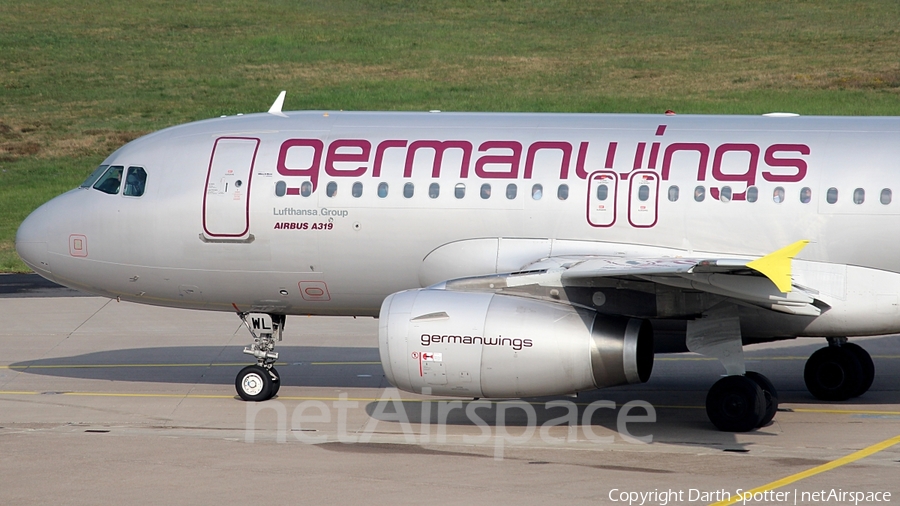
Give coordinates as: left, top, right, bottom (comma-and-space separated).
0, 278, 900, 504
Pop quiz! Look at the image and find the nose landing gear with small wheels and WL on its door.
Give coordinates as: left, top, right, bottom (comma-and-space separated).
234, 313, 285, 402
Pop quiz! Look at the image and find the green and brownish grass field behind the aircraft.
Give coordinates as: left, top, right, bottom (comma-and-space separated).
0, 0, 900, 271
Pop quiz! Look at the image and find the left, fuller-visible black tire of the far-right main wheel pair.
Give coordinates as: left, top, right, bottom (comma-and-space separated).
803, 346, 863, 401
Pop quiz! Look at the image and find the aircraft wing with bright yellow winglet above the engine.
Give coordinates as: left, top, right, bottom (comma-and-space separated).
439, 241, 828, 316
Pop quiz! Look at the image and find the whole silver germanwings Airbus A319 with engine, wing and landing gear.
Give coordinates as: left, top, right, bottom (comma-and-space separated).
16, 92, 900, 431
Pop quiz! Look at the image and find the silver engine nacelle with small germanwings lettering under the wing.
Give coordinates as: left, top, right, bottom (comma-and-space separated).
378, 289, 653, 397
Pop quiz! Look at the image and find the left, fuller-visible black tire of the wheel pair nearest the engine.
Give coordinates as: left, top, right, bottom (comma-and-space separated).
706, 376, 766, 432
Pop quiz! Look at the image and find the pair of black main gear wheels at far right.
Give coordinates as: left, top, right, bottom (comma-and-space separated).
803, 338, 875, 401
